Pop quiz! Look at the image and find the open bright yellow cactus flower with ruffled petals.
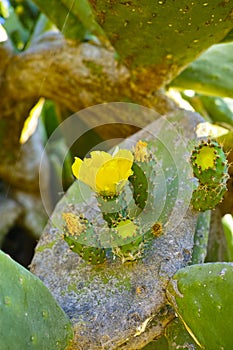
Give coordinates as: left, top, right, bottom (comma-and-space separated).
72, 150, 133, 196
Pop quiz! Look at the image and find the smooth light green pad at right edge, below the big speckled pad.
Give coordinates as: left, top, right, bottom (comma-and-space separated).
171, 42, 233, 97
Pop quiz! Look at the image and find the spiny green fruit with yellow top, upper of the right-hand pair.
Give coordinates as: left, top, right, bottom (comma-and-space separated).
191, 140, 228, 187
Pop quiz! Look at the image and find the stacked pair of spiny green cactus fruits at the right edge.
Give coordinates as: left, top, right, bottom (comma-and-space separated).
191, 140, 229, 211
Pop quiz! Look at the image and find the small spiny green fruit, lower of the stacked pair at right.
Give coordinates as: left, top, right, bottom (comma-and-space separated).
191, 184, 227, 211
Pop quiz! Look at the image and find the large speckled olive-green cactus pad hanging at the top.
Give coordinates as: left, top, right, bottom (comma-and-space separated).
90, 0, 232, 86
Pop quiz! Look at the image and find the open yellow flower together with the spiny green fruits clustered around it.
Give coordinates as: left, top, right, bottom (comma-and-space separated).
63, 140, 162, 264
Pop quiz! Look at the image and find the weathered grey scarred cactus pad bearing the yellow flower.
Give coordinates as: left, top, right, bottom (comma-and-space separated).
31, 108, 202, 350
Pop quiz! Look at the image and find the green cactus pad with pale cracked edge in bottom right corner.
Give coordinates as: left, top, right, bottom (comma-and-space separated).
167, 263, 233, 350
